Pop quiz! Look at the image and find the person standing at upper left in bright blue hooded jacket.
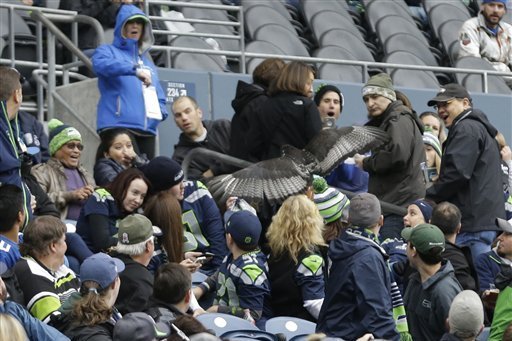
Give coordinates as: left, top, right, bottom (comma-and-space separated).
92, 5, 168, 160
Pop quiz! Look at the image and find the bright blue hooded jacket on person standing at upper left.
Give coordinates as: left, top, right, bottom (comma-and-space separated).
92, 5, 168, 135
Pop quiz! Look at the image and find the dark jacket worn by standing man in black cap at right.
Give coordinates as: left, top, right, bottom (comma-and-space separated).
427, 108, 505, 232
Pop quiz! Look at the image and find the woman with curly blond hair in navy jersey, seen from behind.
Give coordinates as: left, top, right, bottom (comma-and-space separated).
266, 194, 327, 321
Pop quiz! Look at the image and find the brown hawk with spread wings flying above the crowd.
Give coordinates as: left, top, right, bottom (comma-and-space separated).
208, 127, 389, 205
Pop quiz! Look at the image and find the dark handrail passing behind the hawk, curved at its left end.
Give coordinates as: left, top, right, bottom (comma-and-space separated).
181, 147, 407, 216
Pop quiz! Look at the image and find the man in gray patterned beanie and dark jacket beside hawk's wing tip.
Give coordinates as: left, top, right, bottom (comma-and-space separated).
354, 73, 426, 240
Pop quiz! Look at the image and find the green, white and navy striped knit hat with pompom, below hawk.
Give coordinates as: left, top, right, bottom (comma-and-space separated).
313, 176, 350, 224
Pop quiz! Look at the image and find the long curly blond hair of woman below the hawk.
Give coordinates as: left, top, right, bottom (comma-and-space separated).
266, 194, 326, 263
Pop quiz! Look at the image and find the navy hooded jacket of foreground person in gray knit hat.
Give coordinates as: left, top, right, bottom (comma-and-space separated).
316, 230, 400, 341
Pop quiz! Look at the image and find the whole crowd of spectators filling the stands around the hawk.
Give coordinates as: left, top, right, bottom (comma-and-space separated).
0, 1, 512, 340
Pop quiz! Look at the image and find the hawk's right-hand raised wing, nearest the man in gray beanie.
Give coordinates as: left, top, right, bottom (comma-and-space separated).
304, 127, 389, 176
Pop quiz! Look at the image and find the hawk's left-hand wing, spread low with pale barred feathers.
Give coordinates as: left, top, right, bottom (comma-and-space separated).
208, 150, 311, 205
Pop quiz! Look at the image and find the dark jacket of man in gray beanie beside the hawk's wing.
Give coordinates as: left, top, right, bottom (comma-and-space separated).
363, 101, 426, 206
